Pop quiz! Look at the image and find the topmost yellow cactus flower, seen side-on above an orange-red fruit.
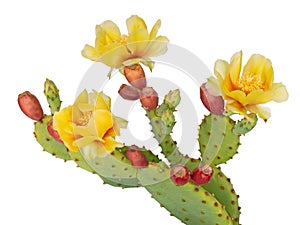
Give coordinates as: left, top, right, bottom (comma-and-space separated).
82, 16, 169, 69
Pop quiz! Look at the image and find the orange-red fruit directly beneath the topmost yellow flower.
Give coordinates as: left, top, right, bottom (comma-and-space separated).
124, 64, 147, 89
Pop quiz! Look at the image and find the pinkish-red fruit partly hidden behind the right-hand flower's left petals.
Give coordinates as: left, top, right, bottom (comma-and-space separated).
200, 83, 224, 115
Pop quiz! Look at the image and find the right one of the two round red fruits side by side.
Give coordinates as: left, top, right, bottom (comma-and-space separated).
191, 165, 214, 185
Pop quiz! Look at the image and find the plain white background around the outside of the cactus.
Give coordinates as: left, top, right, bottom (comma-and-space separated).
0, 0, 300, 225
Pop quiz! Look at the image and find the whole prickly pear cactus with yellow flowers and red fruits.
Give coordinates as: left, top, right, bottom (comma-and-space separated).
18, 16, 287, 225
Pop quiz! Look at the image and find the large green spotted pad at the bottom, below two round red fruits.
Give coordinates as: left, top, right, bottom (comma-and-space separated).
145, 179, 233, 225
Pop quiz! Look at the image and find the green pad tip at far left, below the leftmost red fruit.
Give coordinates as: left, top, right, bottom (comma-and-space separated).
34, 116, 71, 160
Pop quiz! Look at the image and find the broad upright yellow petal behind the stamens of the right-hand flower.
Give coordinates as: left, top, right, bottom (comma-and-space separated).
243, 54, 274, 90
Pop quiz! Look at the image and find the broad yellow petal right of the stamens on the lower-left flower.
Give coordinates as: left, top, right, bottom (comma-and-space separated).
93, 110, 114, 139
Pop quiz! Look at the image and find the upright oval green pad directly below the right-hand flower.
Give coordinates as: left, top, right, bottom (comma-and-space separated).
198, 114, 240, 165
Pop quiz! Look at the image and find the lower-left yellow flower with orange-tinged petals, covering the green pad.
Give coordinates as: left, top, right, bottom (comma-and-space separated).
53, 90, 127, 157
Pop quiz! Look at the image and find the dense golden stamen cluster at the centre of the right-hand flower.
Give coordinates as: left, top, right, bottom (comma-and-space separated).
238, 73, 264, 95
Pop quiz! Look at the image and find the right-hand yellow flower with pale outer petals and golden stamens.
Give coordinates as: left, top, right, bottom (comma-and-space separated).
206, 51, 288, 121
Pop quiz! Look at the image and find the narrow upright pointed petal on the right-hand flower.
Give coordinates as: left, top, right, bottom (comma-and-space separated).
228, 51, 242, 88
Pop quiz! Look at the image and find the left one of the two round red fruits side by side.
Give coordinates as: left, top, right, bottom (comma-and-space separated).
170, 164, 191, 186
